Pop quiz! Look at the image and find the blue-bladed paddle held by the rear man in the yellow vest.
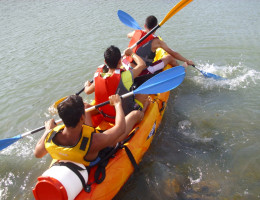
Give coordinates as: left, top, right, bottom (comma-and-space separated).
0, 66, 185, 150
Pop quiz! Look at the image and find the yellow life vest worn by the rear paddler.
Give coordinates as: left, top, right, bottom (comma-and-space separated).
44, 125, 97, 166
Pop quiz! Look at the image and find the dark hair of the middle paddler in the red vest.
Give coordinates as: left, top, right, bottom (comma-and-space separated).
104, 45, 121, 69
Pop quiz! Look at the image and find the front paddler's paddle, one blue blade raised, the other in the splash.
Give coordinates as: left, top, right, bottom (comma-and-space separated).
117, 10, 225, 80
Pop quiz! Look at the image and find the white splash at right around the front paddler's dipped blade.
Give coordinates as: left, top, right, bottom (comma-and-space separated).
191, 62, 260, 90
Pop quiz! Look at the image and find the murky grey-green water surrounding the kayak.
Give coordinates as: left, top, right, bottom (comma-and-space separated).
0, 0, 260, 200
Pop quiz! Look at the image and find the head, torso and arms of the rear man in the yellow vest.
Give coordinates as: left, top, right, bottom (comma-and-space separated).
34, 95, 129, 166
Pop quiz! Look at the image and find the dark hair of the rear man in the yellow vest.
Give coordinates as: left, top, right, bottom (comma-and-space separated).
58, 95, 85, 128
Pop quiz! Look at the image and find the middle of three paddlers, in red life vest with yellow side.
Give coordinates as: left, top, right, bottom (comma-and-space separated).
85, 45, 149, 132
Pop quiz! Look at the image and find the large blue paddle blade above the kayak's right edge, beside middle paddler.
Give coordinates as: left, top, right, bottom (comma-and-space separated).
133, 66, 185, 94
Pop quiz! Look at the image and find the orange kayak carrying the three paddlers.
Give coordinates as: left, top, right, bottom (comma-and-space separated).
33, 47, 173, 200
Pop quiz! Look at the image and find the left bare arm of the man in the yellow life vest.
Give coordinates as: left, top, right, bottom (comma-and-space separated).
34, 119, 56, 158
